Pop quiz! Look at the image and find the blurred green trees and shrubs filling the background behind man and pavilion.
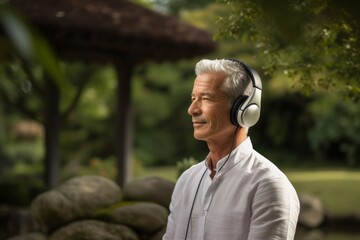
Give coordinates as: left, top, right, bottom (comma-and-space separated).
0, 1, 359, 208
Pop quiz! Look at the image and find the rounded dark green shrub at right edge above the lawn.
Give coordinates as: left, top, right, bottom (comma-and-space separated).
309, 96, 360, 166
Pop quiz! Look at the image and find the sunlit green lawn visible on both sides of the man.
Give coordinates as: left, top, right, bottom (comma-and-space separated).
141, 167, 360, 214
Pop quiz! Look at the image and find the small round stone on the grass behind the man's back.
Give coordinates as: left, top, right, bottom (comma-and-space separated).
298, 194, 326, 228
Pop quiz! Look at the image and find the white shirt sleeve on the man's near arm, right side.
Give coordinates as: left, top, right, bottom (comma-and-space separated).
248, 178, 300, 240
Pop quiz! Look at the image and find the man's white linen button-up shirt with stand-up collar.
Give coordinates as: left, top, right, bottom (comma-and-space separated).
163, 138, 300, 240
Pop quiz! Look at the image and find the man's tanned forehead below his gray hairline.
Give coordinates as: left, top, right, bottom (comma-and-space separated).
193, 72, 225, 93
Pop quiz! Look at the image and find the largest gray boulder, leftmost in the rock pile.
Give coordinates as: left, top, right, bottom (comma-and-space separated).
31, 176, 122, 231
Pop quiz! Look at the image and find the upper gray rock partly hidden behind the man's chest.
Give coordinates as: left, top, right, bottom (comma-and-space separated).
124, 177, 175, 208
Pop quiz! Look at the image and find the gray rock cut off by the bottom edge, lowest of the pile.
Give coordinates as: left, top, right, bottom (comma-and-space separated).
50, 220, 139, 240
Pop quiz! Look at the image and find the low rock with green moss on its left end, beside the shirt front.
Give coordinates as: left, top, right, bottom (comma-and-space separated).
104, 202, 169, 233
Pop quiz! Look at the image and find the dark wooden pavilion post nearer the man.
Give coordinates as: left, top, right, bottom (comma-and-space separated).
114, 58, 133, 188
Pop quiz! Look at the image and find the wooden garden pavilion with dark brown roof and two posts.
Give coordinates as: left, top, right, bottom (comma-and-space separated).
10, 0, 216, 188
